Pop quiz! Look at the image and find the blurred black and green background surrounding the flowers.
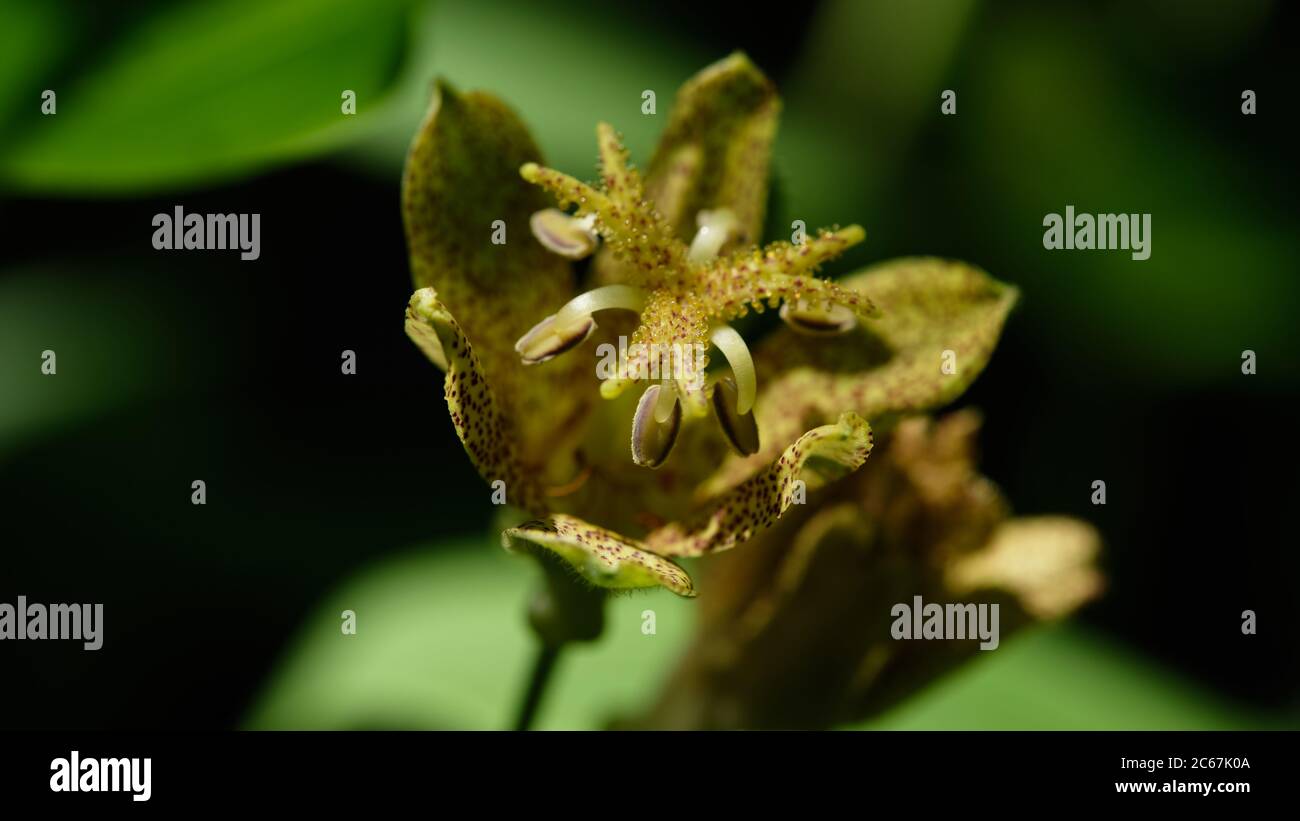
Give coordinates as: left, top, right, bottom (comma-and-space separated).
0, 0, 1300, 729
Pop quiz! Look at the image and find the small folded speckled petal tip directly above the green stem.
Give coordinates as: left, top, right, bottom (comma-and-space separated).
502, 513, 696, 596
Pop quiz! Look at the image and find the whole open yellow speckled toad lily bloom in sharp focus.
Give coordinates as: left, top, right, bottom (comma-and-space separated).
403, 55, 1050, 610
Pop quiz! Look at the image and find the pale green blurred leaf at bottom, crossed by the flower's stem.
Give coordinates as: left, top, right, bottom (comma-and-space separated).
244, 539, 694, 730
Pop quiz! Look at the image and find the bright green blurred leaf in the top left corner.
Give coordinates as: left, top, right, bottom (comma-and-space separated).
0, 0, 410, 194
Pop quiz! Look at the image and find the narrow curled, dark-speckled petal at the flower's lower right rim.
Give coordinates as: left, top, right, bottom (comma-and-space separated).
646, 413, 872, 556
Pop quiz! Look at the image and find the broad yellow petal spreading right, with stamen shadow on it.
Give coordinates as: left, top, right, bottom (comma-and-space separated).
701, 257, 1017, 495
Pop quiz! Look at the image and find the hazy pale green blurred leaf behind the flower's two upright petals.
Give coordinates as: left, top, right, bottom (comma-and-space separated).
340, 0, 707, 179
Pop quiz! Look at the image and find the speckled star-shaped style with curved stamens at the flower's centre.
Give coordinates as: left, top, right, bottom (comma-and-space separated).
515, 123, 875, 468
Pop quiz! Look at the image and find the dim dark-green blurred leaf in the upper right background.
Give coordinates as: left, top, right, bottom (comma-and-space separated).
954, 6, 1300, 383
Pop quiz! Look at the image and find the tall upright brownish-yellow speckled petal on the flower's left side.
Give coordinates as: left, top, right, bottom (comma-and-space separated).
402, 82, 593, 475
